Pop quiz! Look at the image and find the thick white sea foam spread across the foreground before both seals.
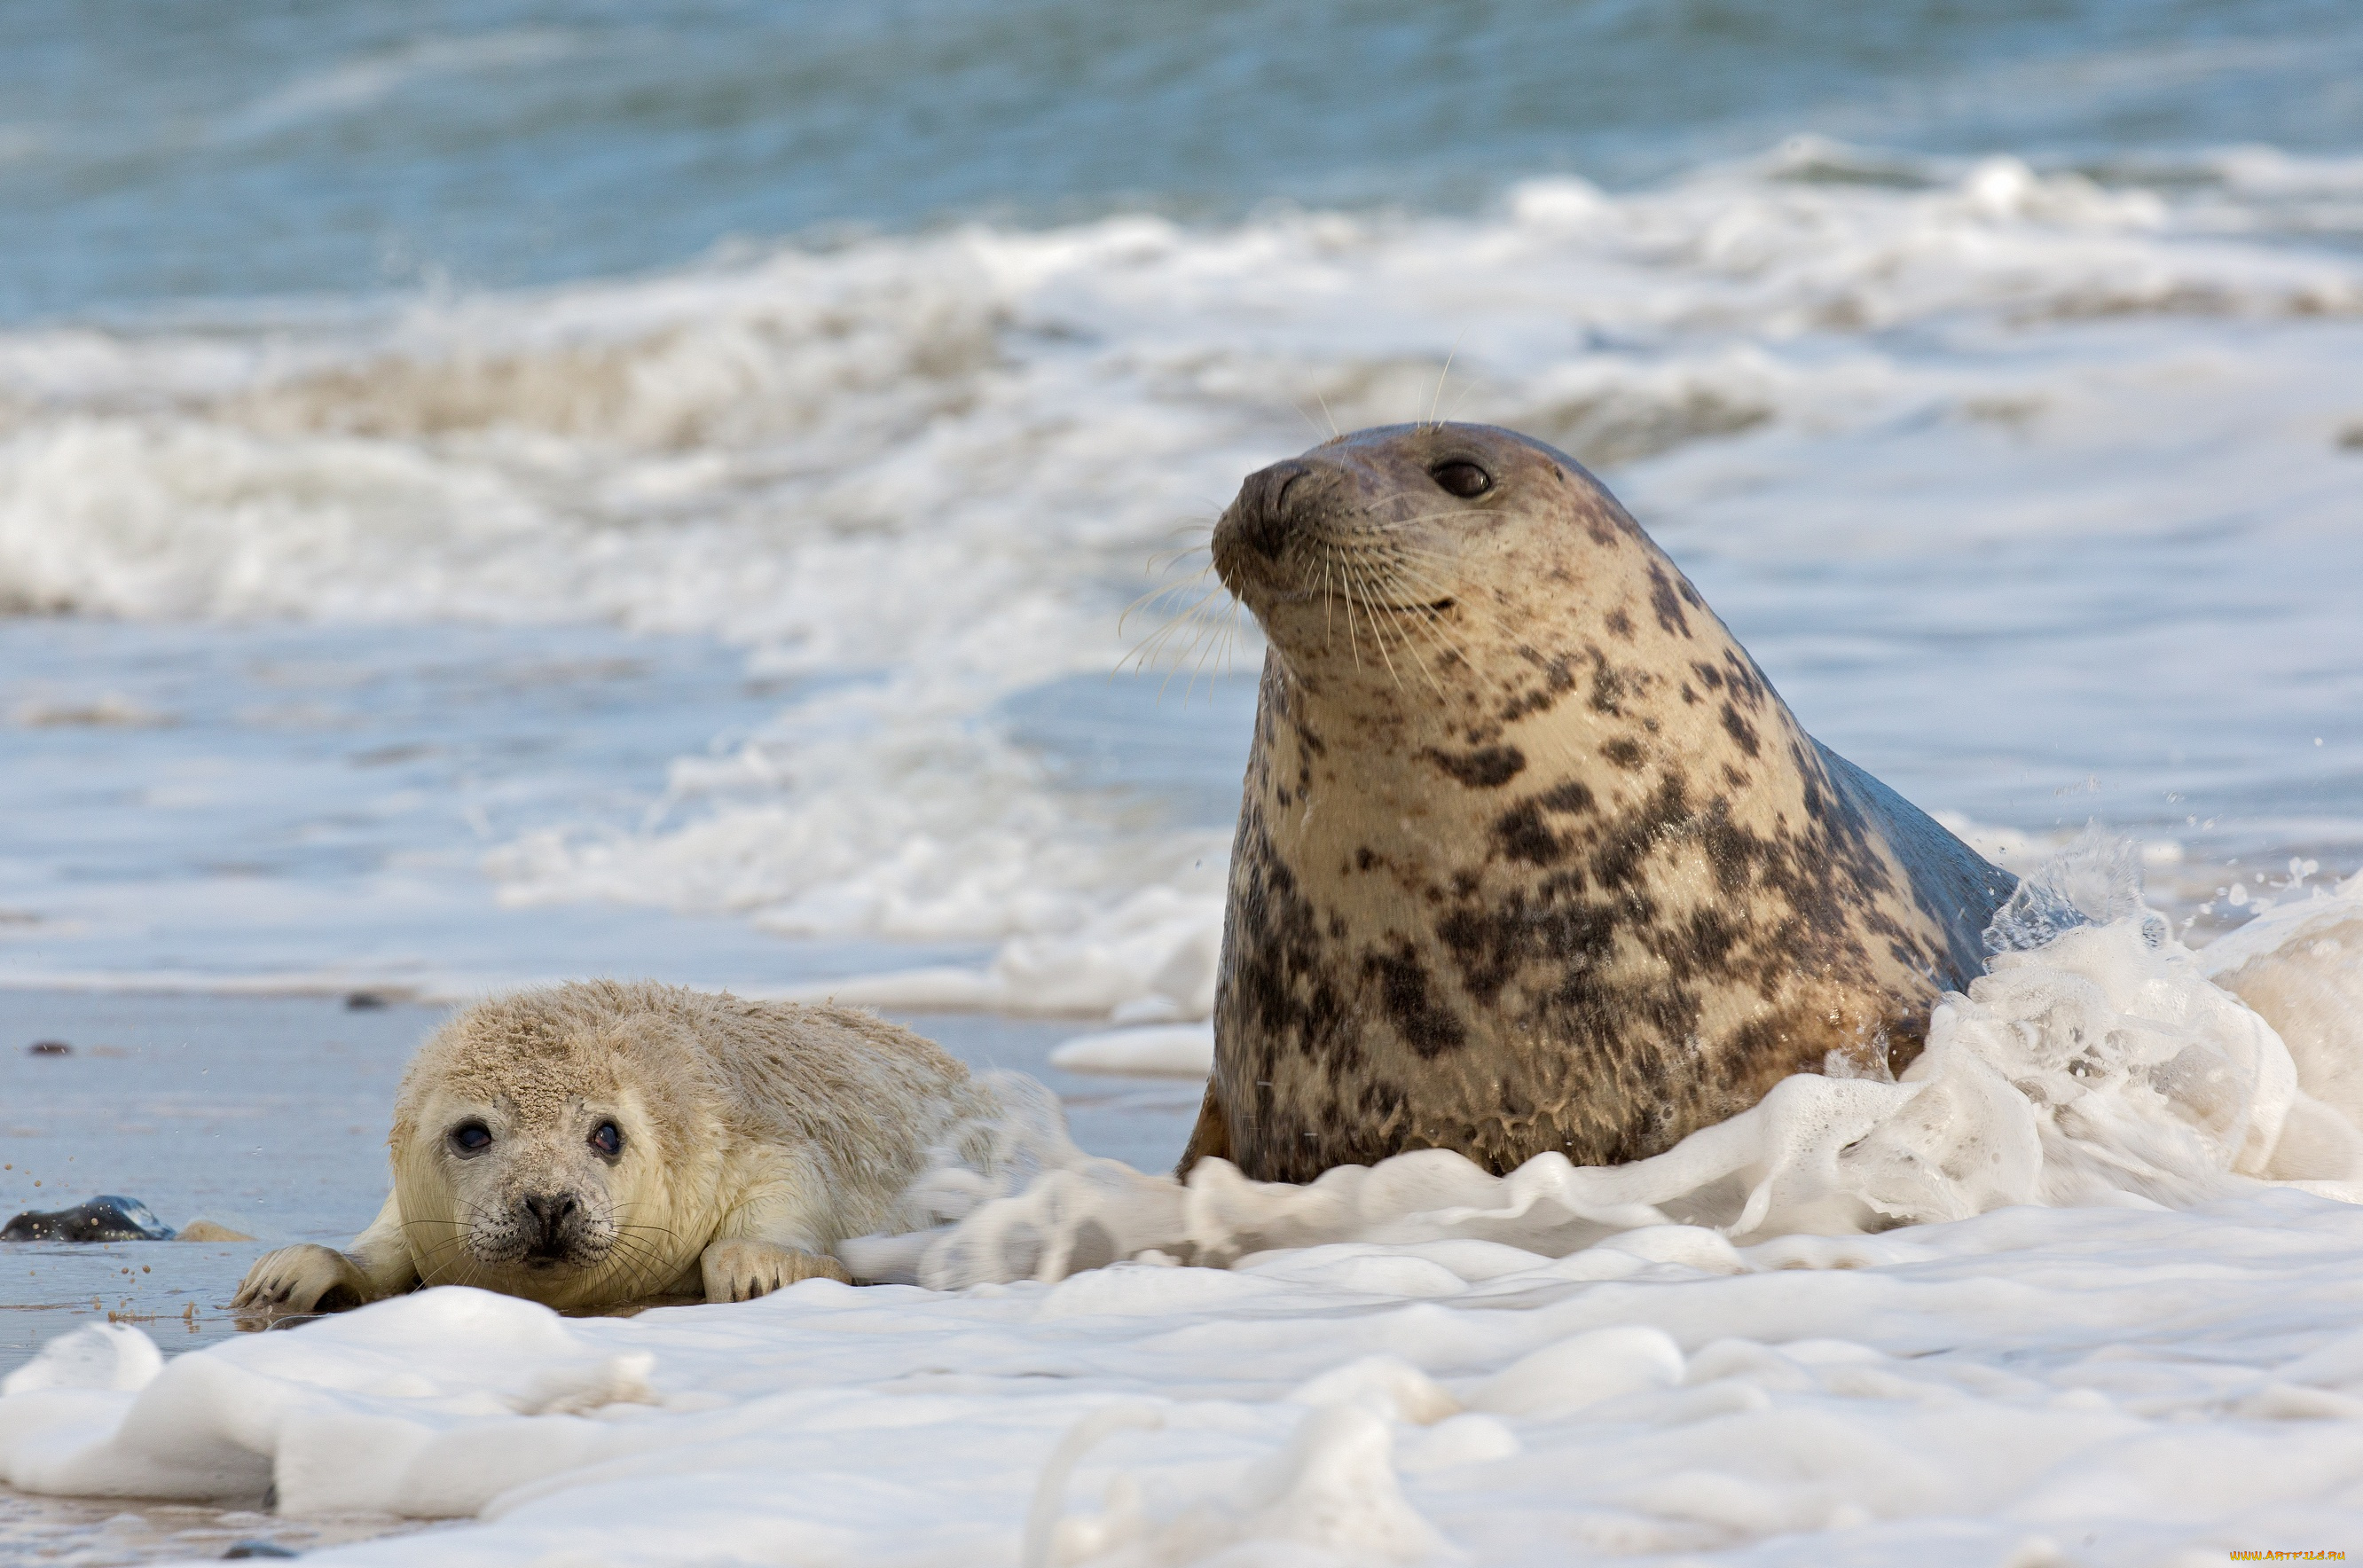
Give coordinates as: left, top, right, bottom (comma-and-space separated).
0, 885, 2363, 1568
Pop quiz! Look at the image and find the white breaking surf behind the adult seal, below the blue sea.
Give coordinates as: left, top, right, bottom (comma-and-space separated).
0, 144, 2363, 1018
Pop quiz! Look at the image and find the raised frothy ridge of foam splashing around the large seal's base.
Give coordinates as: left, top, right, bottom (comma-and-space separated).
848, 868, 2363, 1290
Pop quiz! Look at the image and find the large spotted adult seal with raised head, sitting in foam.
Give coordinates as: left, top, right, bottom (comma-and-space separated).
1182, 423, 2015, 1180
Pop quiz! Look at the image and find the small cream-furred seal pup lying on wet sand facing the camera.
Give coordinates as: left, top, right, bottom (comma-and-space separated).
234, 980, 997, 1313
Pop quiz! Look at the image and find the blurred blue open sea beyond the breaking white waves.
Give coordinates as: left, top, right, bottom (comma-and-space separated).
0, 0, 2363, 321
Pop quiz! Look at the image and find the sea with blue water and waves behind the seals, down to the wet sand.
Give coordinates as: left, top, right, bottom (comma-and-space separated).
0, 3, 2363, 1020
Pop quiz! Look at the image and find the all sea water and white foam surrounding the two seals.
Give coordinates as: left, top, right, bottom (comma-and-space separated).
0, 0, 2363, 1568
